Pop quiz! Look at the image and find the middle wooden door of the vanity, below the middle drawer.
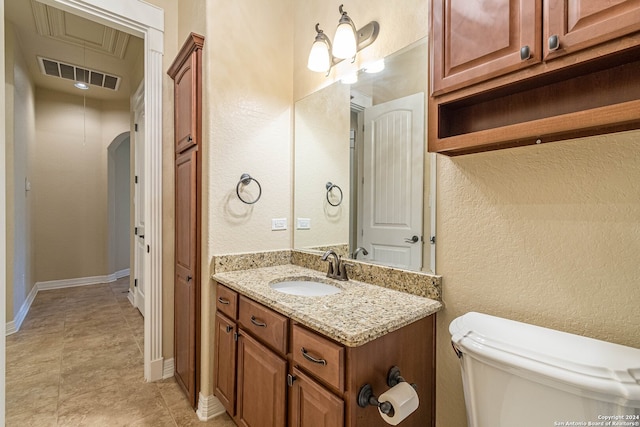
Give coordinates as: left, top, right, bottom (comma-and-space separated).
236, 329, 287, 427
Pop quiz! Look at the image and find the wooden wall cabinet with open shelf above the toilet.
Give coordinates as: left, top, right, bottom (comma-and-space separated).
428, 0, 640, 155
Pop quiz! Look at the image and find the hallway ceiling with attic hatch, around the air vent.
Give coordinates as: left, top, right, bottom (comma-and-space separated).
5, 0, 144, 100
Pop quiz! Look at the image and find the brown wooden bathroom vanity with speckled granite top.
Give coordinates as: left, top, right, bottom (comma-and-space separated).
213, 265, 441, 427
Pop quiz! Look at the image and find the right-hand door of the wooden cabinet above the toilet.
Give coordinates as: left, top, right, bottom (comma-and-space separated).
544, 0, 640, 59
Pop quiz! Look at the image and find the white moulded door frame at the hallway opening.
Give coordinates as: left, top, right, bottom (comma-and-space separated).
38, 0, 164, 381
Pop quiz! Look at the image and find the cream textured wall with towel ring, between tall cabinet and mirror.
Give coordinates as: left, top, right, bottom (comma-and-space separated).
198, 0, 293, 396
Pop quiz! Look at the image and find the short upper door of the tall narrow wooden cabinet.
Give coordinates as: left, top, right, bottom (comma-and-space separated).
174, 55, 197, 153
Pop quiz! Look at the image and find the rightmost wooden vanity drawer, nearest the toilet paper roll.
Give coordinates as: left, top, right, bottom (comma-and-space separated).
291, 325, 344, 392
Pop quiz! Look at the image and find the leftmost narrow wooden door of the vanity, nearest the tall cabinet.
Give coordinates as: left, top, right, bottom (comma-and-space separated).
213, 313, 237, 416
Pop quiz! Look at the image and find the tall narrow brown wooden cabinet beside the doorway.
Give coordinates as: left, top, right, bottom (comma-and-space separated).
168, 33, 204, 408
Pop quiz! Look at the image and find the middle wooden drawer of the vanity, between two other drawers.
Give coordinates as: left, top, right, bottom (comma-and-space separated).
238, 295, 289, 355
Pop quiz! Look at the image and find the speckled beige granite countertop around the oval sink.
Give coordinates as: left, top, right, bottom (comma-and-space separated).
211, 264, 442, 347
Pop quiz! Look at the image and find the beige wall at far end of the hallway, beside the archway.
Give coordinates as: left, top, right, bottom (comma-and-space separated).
32, 88, 129, 282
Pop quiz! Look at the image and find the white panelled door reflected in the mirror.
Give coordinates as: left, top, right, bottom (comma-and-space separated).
359, 93, 424, 270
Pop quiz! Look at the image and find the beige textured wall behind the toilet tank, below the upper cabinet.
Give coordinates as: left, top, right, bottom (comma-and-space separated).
436, 132, 640, 427
